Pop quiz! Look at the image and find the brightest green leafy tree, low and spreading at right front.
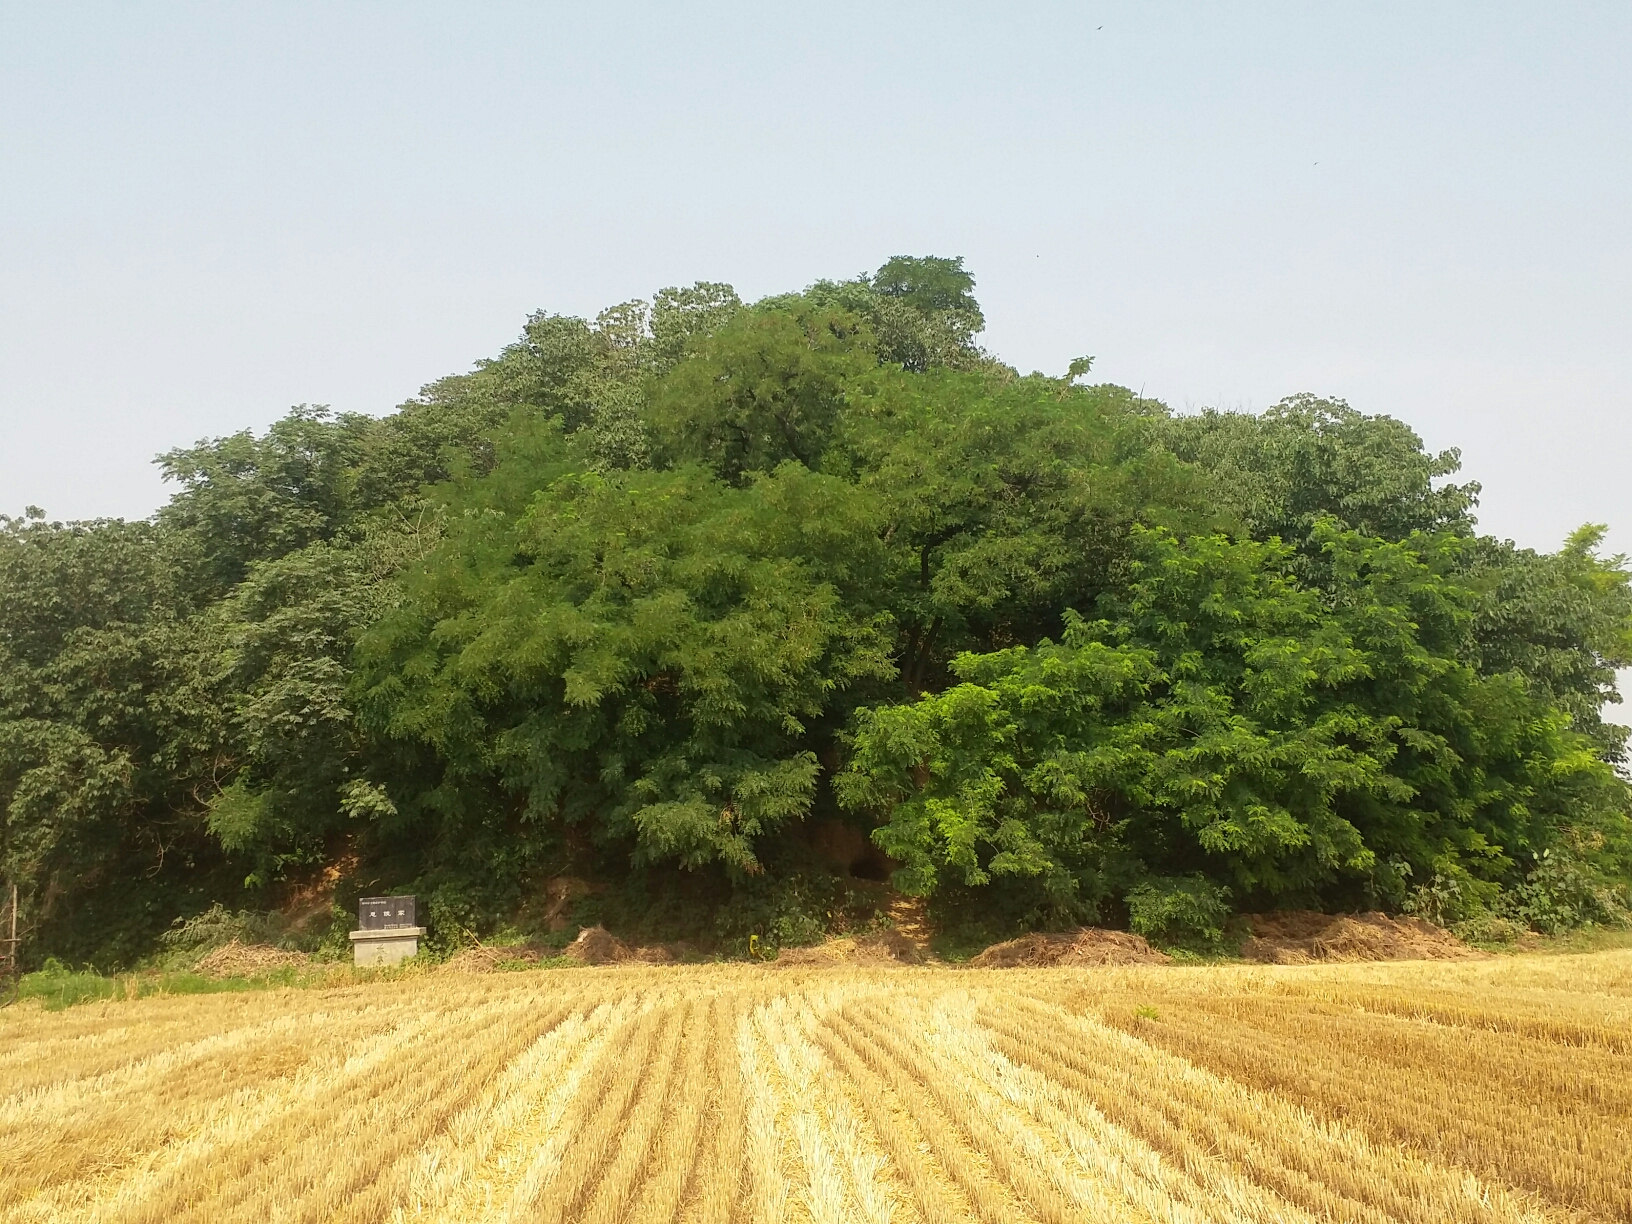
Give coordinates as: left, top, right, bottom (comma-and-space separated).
840, 521, 1625, 914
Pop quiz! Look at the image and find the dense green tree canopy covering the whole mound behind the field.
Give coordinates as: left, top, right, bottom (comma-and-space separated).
0, 256, 1632, 963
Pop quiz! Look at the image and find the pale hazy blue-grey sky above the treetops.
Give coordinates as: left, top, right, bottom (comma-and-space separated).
0, 0, 1632, 550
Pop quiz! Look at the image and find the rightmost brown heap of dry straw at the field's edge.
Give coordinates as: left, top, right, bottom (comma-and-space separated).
1240, 909, 1488, 965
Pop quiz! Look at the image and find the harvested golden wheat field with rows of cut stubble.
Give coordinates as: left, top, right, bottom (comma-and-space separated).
0, 951, 1632, 1224
